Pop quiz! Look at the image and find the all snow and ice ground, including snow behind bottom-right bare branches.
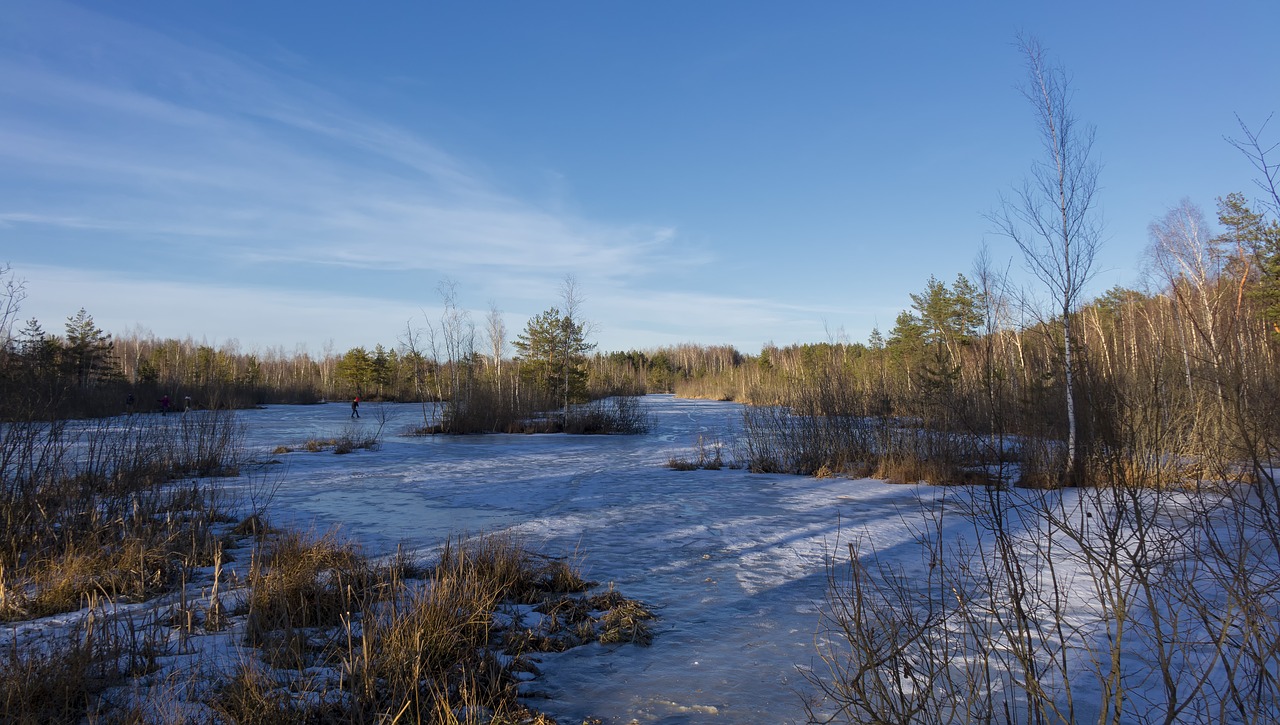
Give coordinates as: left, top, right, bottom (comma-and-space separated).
15, 396, 1264, 725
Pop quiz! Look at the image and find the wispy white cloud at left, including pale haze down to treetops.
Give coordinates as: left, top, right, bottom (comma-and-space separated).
0, 0, 849, 347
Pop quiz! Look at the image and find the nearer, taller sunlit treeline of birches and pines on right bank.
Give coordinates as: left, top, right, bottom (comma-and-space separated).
675, 193, 1280, 485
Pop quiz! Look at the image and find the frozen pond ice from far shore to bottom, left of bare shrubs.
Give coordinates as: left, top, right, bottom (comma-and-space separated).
230, 396, 936, 724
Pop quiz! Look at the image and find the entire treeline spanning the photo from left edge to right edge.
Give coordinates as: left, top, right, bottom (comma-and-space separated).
0, 184, 1280, 471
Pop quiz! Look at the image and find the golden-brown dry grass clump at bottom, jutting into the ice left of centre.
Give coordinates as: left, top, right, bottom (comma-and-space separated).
211, 533, 650, 722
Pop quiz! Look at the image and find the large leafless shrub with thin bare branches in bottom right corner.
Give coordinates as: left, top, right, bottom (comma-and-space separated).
810, 458, 1280, 722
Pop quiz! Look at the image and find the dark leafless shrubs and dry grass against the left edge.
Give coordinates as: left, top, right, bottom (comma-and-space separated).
0, 414, 238, 620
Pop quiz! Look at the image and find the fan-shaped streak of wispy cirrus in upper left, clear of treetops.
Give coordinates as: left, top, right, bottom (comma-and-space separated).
0, 3, 673, 289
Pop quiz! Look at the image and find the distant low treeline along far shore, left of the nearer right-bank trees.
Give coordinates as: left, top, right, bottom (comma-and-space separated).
0, 310, 727, 418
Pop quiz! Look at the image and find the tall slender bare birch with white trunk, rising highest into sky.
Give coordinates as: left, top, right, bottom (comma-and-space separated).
992, 37, 1102, 489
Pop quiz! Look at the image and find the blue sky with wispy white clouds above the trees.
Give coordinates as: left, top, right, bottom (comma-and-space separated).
0, 0, 1280, 352
